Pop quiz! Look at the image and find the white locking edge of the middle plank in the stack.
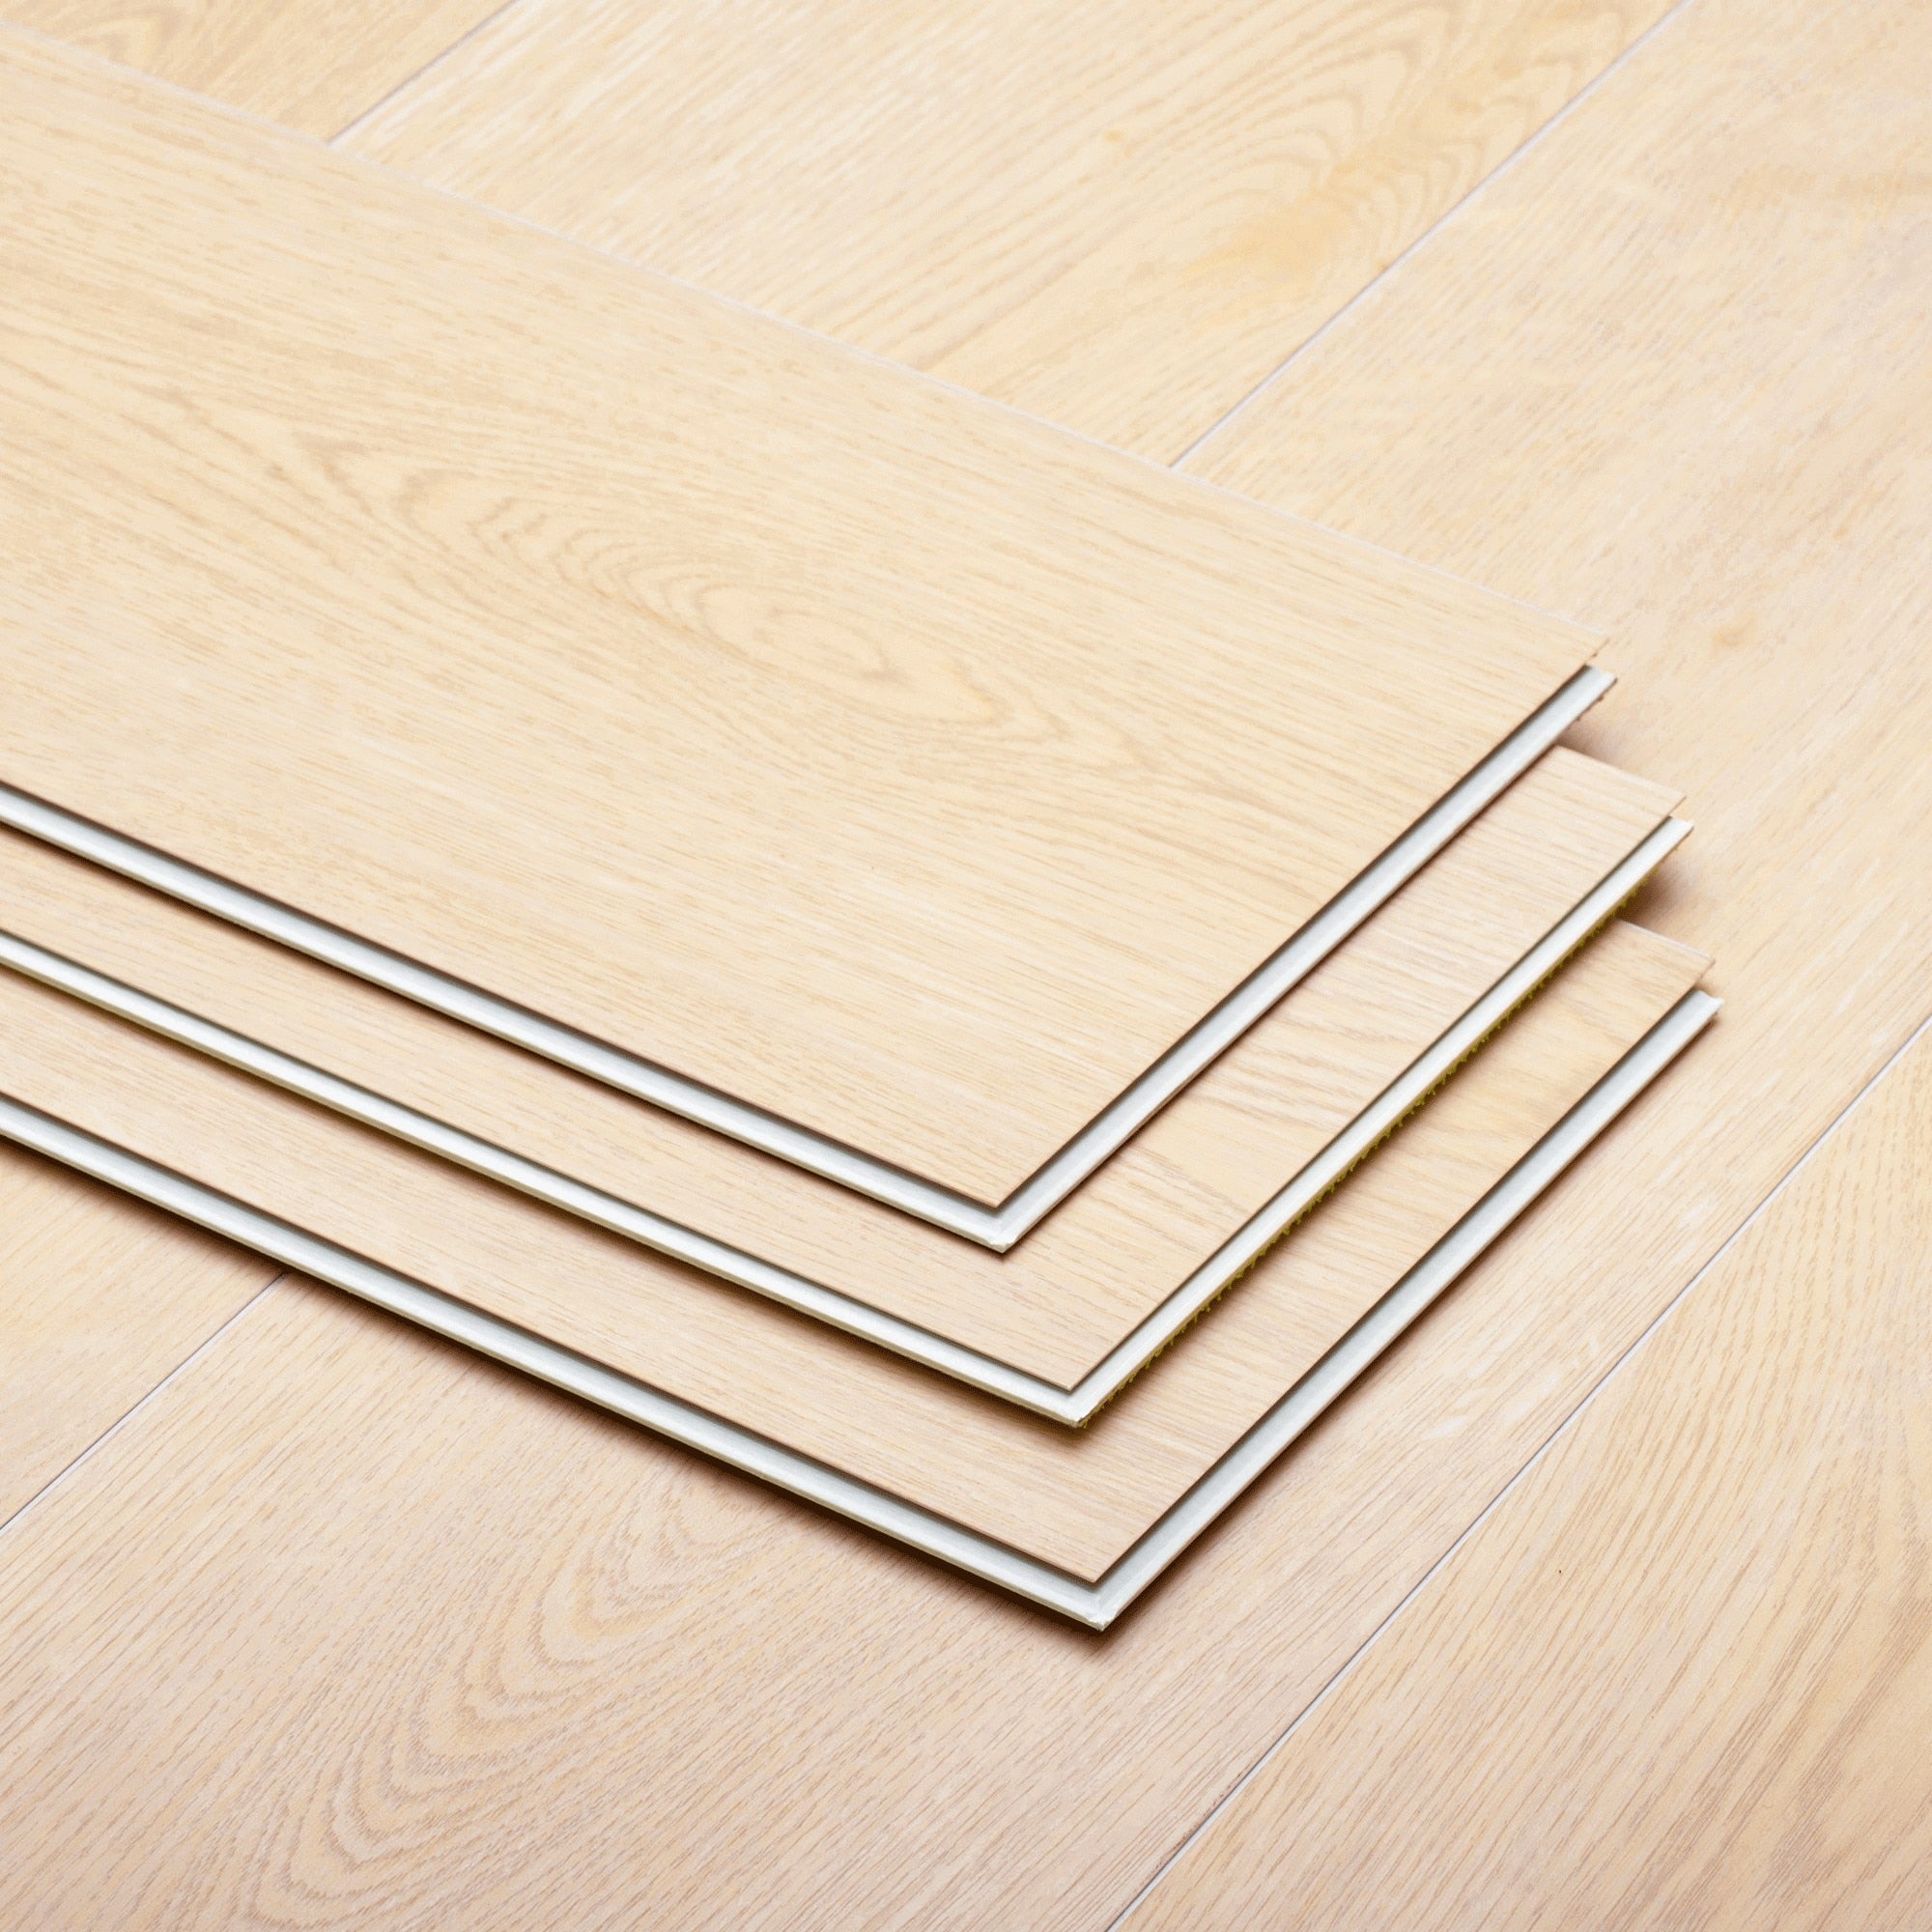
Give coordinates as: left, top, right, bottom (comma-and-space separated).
0, 819, 1690, 1426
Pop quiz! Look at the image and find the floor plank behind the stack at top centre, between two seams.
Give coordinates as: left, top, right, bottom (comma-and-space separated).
344, 0, 1665, 462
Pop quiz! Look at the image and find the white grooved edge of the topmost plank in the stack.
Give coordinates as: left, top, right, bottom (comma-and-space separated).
0, 665, 1613, 1252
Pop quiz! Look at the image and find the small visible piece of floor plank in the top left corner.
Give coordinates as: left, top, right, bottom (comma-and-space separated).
0, 0, 502, 139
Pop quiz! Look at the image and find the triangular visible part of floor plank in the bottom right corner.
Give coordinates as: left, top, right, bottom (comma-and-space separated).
1130, 1037, 1932, 1932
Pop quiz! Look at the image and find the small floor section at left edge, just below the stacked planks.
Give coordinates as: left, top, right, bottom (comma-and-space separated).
0, 1148, 278, 1520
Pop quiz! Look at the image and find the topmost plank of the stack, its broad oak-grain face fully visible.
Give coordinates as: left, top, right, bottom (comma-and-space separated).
0, 33, 1607, 1215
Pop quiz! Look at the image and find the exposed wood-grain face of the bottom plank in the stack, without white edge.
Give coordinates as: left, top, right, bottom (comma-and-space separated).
0, 925, 1706, 1580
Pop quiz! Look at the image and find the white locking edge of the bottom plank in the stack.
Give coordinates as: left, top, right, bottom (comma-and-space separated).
0, 991, 1719, 1631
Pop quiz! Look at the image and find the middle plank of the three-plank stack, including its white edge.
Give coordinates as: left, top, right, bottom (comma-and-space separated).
0, 750, 1683, 1422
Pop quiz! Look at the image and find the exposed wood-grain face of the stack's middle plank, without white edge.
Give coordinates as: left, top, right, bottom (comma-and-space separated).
0, 750, 1673, 1387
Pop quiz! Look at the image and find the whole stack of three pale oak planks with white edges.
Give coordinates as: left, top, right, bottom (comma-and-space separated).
0, 29, 1716, 1627
